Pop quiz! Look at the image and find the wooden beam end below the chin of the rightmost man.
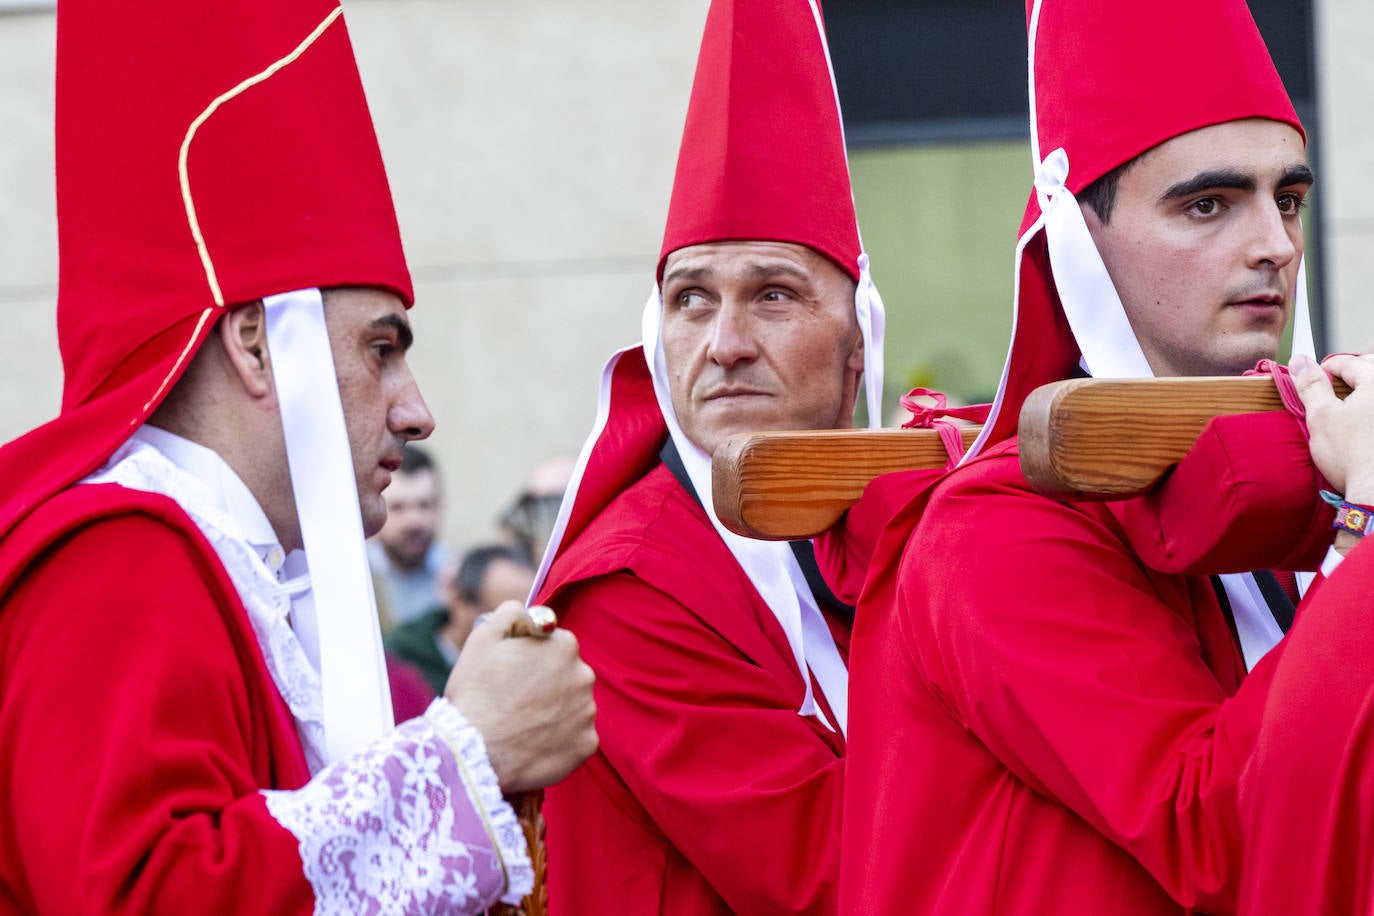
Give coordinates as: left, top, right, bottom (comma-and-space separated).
1020, 376, 1348, 501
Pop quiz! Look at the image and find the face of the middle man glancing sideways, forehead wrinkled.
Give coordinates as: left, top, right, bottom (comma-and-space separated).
662, 242, 863, 453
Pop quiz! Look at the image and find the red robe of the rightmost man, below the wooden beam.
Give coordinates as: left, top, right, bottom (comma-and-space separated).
841, 415, 1319, 916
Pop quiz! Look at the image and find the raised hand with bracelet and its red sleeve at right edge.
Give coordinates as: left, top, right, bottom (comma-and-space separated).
1241, 354, 1374, 916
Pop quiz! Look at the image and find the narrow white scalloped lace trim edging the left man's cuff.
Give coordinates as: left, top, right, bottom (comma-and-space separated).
425, 696, 534, 906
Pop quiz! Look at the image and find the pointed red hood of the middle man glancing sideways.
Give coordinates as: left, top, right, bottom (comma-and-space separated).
658, 0, 861, 280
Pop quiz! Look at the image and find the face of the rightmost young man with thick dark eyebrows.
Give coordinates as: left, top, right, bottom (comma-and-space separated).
1083, 118, 1312, 376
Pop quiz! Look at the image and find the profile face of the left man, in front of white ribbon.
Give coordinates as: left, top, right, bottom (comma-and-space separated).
324, 288, 434, 536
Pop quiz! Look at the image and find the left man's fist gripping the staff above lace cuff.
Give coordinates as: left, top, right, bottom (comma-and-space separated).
444, 602, 596, 794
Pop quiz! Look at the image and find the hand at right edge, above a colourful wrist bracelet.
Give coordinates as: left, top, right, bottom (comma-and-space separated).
1289, 354, 1374, 505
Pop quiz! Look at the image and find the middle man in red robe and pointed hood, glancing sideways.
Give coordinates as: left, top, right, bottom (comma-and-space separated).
537, 0, 882, 915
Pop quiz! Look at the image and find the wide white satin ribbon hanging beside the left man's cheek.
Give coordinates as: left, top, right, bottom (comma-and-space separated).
262, 288, 393, 762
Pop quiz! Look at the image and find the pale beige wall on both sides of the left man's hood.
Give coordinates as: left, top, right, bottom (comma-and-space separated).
0, 0, 706, 544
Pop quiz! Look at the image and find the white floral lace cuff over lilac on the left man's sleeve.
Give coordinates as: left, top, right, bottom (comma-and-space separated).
262, 699, 533, 913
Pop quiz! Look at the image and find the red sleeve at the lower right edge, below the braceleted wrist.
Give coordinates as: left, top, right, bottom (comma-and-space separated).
1241, 538, 1374, 916
